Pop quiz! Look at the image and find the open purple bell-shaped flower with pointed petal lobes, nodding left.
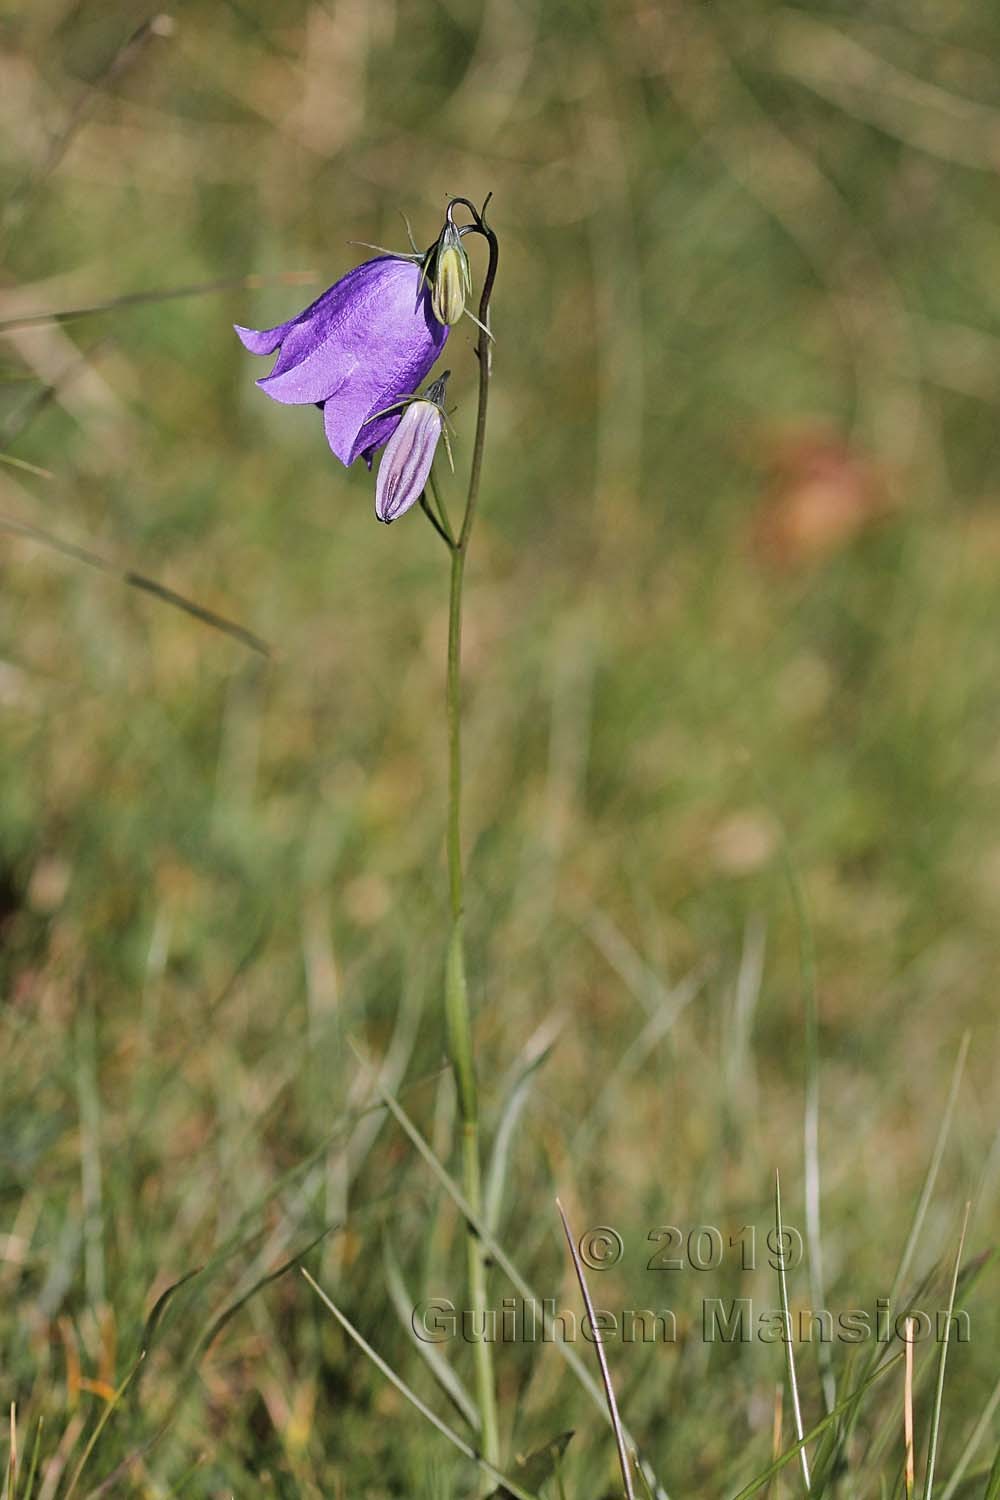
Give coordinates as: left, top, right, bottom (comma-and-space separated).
235, 255, 448, 468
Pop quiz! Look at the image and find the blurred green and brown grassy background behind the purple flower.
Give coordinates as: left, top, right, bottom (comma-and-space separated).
0, 0, 1000, 1500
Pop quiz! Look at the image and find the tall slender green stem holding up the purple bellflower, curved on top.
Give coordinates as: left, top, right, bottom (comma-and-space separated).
435, 200, 499, 1488
